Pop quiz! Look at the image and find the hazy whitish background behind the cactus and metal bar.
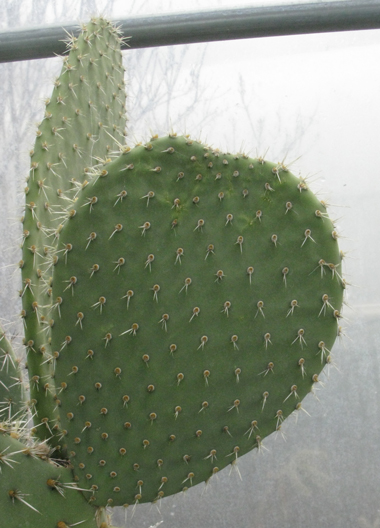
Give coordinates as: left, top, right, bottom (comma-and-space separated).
0, 0, 380, 528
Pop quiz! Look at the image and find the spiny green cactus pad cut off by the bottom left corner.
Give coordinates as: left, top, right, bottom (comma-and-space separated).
0, 432, 97, 528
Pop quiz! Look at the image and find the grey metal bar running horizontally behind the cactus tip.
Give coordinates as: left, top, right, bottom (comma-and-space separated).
0, 0, 380, 62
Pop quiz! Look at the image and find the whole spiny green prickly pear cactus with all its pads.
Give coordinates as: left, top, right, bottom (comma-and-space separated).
0, 14, 346, 528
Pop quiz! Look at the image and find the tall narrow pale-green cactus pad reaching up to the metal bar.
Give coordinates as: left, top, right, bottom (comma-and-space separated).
20, 15, 126, 446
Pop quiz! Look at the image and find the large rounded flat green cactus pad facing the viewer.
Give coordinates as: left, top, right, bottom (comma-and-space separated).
52, 134, 345, 506
